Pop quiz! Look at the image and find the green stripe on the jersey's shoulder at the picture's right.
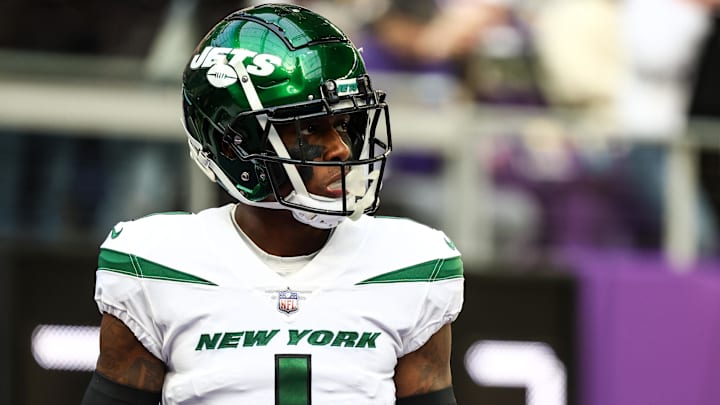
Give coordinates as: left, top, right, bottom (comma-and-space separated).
356, 256, 463, 285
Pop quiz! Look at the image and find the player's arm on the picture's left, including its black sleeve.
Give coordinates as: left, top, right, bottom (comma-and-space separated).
81, 314, 165, 405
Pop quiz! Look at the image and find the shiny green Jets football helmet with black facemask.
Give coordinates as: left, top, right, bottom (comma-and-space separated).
183, 4, 392, 228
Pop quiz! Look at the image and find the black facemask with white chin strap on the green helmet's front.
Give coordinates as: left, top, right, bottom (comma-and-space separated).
225, 77, 391, 228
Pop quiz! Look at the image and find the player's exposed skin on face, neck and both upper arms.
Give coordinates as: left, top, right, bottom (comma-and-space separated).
97, 117, 452, 398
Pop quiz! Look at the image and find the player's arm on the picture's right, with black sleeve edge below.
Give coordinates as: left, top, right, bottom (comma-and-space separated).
395, 324, 456, 405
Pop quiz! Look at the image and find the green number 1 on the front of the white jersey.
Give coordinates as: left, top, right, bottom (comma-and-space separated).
275, 354, 310, 405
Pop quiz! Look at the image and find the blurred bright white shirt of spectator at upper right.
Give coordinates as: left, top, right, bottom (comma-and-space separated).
616, 0, 710, 140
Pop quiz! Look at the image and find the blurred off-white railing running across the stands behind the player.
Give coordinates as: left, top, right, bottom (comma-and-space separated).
0, 73, 720, 269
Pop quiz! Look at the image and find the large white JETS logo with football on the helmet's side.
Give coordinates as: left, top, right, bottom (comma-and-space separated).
190, 46, 282, 88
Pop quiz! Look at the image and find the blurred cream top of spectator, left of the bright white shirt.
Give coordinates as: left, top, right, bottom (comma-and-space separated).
530, 0, 622, 117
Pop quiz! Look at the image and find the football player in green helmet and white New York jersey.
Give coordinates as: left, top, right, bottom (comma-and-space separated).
82, 5, 463, 405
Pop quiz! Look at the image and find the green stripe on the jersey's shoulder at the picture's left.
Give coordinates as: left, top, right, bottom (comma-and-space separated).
98, 248, 216, 285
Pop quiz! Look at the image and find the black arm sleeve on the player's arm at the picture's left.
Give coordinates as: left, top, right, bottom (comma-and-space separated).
80, 372, 160, 405
